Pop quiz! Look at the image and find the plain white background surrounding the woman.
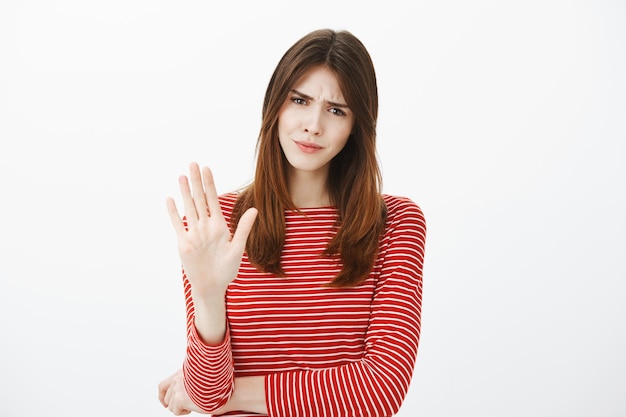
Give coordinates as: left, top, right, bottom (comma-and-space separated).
0, 0, 626, 417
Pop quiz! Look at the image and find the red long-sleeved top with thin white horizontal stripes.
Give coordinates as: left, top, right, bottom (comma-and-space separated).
183, 194, 426, 417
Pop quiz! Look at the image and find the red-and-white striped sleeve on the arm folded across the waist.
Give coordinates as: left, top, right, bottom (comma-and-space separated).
265, 198, 426, 417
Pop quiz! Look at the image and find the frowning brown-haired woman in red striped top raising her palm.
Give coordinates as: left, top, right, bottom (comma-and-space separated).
159, 30, 426, 416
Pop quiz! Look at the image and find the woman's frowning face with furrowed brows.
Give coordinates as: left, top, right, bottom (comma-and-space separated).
278, 66, 354, 176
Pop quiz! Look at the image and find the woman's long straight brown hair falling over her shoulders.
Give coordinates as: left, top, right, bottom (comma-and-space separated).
231, 29, 386, 287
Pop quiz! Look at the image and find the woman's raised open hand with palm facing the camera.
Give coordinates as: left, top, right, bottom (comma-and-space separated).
167, 163, 257, 301
